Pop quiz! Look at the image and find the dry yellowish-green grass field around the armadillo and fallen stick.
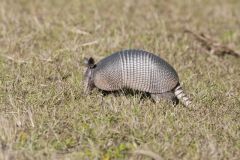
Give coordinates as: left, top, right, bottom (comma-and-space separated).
0, 0, 240, 160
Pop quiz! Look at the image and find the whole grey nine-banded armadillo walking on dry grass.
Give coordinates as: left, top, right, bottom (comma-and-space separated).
84, 49, 191, 106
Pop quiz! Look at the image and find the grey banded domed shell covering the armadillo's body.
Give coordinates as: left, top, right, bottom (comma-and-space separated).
94, 49, 179, 93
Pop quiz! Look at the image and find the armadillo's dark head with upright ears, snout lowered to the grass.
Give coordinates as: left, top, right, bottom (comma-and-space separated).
84, 57, 96, 94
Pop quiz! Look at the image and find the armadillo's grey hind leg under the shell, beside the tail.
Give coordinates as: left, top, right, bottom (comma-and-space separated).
151, 91, 179, 105
